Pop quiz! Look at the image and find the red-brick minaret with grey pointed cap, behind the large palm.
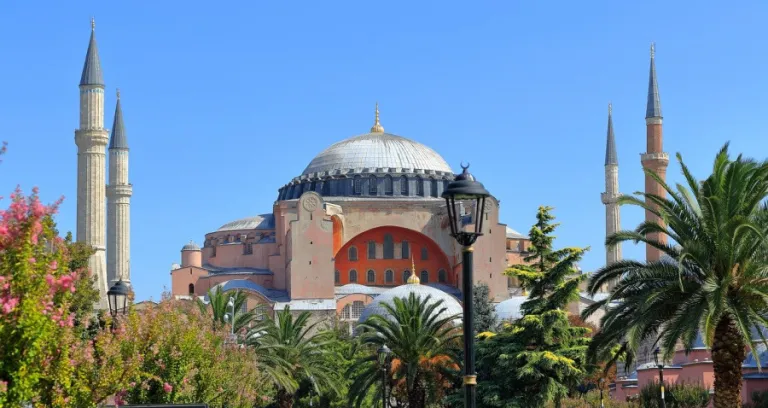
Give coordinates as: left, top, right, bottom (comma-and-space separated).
640, 43, 669, 261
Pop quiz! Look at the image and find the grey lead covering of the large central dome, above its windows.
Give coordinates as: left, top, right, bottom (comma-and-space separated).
302, 133, 453, 175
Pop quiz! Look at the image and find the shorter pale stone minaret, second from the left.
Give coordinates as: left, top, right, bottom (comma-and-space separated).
107, 90, 133, 285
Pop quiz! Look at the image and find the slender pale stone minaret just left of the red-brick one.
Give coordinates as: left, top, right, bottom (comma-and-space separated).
600, 104, 621, 278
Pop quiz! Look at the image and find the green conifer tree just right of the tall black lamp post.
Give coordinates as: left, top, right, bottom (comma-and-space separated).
477, 207, 589, 407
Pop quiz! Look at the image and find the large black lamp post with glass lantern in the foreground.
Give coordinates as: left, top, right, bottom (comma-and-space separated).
443, 165, 491, 408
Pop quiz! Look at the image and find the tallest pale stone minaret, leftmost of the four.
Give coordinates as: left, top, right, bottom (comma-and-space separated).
75, 19, 109, 308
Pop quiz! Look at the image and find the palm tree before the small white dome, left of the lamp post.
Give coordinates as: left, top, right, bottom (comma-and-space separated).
349, 293, 461, 408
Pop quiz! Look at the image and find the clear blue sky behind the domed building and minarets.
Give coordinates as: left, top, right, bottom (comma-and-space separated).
0, 0, 768, 299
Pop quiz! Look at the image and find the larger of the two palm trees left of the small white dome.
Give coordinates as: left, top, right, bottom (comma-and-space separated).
246, 307, 339, 408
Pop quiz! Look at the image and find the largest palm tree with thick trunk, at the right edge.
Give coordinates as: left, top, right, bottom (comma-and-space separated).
583, 144, 768, 408
